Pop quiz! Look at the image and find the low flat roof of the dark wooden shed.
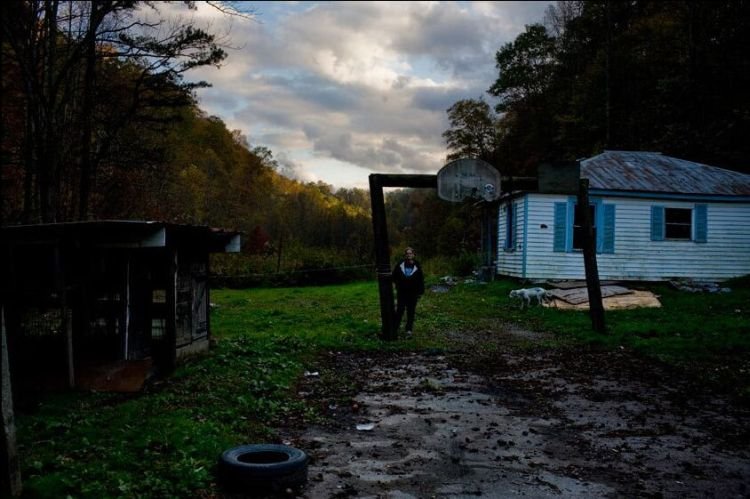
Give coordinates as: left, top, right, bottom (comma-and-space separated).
0, 220, 240, 253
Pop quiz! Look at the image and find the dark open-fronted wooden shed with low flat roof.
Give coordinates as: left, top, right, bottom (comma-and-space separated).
0, 220, 240, 387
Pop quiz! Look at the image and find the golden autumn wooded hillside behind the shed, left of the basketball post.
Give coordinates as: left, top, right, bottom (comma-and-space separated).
0, 2, 372, 282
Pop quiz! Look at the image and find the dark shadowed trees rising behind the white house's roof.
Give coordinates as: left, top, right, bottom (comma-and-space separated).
444, 0, 750, 175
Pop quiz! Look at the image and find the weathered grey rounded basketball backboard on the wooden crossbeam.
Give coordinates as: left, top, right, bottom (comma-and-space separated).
437, 158, 500, 203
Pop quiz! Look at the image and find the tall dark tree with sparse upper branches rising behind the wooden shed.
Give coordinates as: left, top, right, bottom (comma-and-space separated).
0, 0, 226, 222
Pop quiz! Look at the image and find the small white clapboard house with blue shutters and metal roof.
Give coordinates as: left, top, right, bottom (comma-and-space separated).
496, 151, 750, 281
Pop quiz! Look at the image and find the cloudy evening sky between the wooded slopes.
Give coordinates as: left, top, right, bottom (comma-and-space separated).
175, 2, 550, 187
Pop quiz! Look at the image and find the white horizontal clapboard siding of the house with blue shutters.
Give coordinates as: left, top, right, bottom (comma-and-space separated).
498, 194, 750, 280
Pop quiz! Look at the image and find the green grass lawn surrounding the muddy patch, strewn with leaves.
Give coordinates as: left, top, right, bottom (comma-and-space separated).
17, 278, 750, 498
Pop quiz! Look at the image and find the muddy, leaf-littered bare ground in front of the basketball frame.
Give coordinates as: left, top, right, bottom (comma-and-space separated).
279, 327, 750, 498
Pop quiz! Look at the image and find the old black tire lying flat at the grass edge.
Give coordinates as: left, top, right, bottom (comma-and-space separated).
219, 444, 309, 494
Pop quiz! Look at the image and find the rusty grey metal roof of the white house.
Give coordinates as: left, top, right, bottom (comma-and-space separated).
581, 151, 750, 196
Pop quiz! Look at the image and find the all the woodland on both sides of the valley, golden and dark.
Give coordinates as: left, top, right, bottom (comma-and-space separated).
0, 1, 750, 284
